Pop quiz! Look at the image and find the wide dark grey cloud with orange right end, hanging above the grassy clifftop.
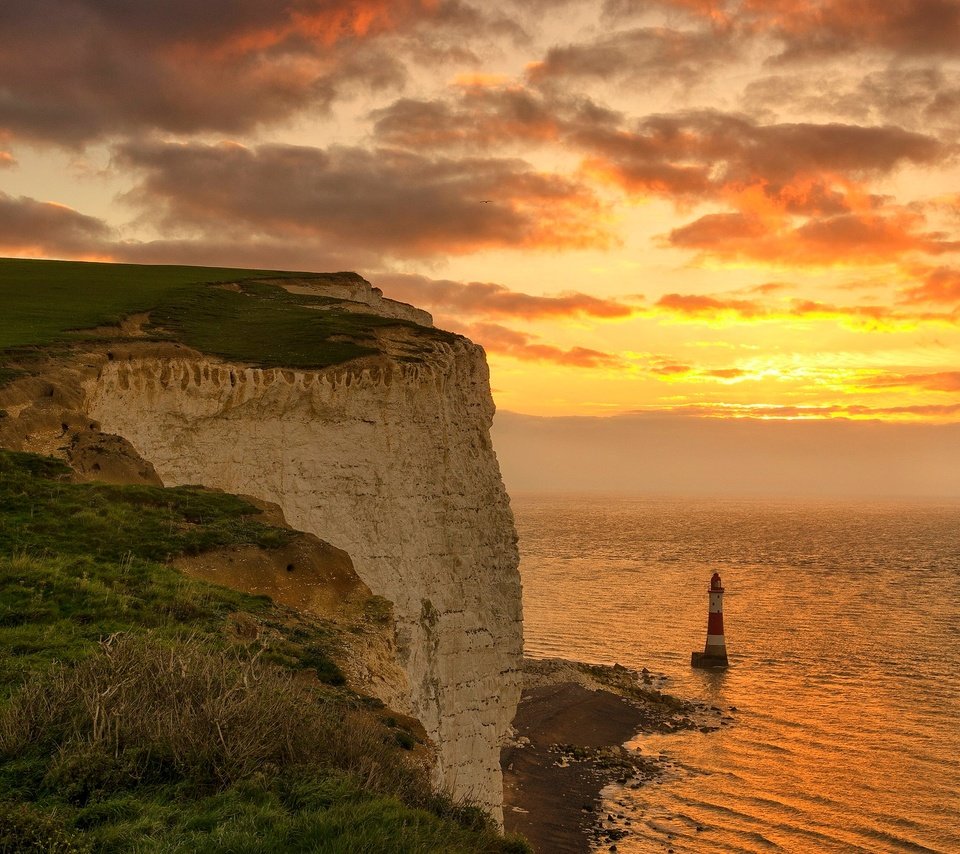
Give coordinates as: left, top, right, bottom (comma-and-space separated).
117, 142, 613, 258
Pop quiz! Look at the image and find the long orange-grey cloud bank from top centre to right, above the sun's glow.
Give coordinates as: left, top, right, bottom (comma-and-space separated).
374, 90, 952, 264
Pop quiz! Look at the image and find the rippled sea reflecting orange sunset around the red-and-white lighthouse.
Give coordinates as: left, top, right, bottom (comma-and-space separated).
513, 496, 960, 852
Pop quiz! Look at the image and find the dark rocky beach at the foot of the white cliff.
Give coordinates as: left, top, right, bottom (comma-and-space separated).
501, 658, 719, 854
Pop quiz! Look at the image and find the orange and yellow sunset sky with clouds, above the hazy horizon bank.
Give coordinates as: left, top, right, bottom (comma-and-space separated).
0, 0, 960, 448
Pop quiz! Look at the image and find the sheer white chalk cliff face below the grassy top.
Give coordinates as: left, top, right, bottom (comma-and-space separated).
84, 336, 522, 817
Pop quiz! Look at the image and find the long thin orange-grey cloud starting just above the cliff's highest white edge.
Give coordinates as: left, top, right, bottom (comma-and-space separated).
376, 273, 634, 320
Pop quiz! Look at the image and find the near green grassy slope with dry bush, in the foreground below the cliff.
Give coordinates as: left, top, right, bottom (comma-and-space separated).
0, 451, 529, 854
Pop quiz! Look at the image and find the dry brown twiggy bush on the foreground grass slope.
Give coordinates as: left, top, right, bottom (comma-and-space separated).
0, 635, 429, 800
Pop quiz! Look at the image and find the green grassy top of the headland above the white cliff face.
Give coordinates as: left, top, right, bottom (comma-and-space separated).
0, 258, 454, 383
